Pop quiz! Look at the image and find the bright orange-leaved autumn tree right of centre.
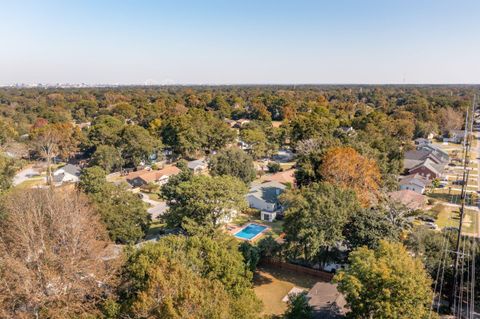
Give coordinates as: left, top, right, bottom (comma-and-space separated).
320, 147, 381, 207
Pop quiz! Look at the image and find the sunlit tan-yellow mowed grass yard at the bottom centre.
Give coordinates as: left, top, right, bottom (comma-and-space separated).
253, 266, 320, 315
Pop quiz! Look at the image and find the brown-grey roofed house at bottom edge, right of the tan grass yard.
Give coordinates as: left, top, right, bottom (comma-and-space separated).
307, 282, 347, 319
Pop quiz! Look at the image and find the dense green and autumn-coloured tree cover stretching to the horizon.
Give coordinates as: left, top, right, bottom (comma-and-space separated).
0, 86, 480, 318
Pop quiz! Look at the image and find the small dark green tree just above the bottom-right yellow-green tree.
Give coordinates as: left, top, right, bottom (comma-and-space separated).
343, 209, 400, 249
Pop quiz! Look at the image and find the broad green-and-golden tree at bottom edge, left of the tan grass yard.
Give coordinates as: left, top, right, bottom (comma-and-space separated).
120, 234, 260, 319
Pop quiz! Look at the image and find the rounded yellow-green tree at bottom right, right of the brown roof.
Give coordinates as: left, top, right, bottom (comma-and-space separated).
335, 240, 432, 319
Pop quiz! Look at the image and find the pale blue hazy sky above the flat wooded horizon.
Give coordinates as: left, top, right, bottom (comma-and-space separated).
0, 0, 480, 85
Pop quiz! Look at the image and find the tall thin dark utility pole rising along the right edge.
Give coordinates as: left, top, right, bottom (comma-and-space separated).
450, 95, 475, 315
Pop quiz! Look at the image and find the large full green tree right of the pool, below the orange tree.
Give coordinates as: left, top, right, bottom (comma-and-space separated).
282, 183, 358, 262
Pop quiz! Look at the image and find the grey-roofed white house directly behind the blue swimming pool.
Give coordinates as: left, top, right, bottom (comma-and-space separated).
247, 181, 287, 221
